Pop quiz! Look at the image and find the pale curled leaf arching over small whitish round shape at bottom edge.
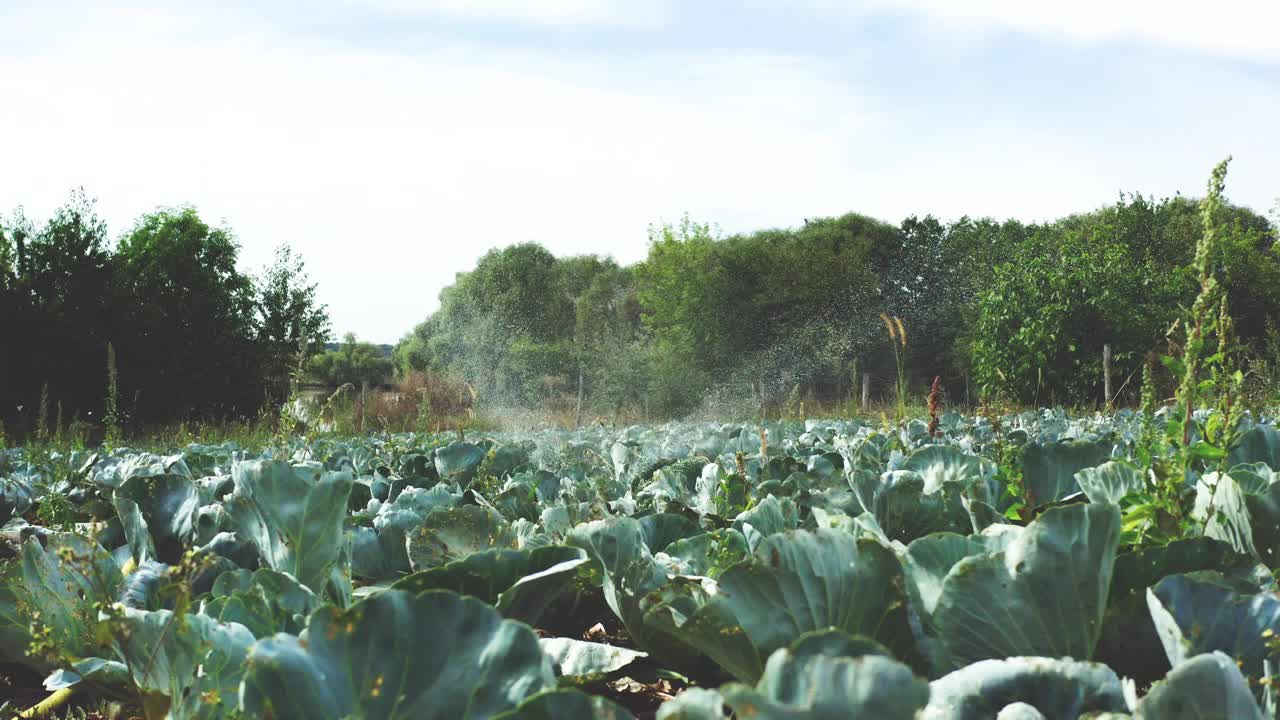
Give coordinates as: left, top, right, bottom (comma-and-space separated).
922, 657, 1128, 720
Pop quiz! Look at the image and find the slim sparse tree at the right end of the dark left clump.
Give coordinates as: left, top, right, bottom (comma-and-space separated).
256, 243, 329, 401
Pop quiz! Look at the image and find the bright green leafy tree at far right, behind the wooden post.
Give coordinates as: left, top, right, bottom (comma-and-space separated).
968, 196, 1280, 404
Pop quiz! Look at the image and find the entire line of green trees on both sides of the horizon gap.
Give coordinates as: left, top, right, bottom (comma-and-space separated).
0, 184, 1280, 434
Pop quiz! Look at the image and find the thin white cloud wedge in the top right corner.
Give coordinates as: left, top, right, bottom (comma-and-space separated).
839, 0, 1280, 61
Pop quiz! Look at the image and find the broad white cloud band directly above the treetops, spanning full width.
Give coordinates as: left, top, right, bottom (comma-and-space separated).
0, 0, 1280, 341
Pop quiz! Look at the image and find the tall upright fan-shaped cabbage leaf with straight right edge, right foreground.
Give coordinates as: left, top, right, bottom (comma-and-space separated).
934, 505, 1120, 667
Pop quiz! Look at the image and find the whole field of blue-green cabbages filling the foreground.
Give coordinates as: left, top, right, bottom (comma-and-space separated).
0, 410, 1280, 720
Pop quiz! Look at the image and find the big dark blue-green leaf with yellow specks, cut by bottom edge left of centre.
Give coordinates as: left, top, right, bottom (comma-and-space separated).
241, 591, 556, 720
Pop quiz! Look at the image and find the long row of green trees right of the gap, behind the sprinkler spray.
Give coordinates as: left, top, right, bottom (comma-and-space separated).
394, 195, 1280, 419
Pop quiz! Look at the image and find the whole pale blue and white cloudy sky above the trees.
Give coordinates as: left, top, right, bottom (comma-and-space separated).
0, 0, 1280, 342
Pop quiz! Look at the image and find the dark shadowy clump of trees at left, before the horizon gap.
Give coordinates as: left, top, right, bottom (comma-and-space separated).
0, 191, 329, 434
